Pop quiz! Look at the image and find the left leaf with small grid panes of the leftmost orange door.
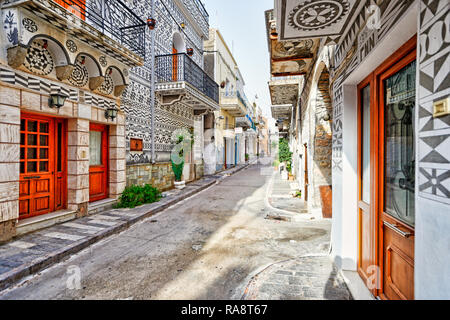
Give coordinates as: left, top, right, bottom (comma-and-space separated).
19, 115, 55, 219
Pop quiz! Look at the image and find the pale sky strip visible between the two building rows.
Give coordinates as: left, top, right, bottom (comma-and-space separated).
202, 0, 274, 117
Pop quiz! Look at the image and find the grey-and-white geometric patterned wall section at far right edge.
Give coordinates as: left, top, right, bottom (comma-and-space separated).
418, 0, 450, 204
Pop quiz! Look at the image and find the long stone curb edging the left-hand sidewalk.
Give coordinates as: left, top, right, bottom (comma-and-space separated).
0, 163, 253, 292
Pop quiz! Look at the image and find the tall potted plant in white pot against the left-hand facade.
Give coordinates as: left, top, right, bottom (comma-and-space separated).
170, 129, 192, 190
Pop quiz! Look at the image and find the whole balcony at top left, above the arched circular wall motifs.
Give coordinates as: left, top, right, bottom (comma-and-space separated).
2, 0, 147, 67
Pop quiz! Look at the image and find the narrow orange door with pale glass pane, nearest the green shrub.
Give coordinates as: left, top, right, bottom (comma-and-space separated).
89, 123, 109, 202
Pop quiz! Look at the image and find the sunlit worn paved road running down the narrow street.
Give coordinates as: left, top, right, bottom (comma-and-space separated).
0, 165, 330, 299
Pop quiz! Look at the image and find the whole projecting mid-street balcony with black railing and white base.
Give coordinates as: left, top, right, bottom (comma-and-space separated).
155, 53, 219, 110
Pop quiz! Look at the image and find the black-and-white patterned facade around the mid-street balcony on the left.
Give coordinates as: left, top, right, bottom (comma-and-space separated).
121, 0, 209, 165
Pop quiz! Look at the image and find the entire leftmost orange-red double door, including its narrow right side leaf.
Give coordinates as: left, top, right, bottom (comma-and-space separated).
19, 114, 62, 219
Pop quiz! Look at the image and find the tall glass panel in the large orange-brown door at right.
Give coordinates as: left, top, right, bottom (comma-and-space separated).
384, 61, 416, 226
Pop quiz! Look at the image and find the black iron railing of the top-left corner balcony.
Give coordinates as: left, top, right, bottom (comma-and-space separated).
53, 0, 146, 57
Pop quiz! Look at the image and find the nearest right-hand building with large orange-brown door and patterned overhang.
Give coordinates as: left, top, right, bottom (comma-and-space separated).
270, 0, 450, 299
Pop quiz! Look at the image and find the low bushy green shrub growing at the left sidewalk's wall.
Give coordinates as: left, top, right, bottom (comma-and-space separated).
115, 184, 162, 209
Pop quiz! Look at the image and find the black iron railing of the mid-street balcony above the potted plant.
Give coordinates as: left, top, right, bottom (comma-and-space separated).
155, 53, 219, 103
